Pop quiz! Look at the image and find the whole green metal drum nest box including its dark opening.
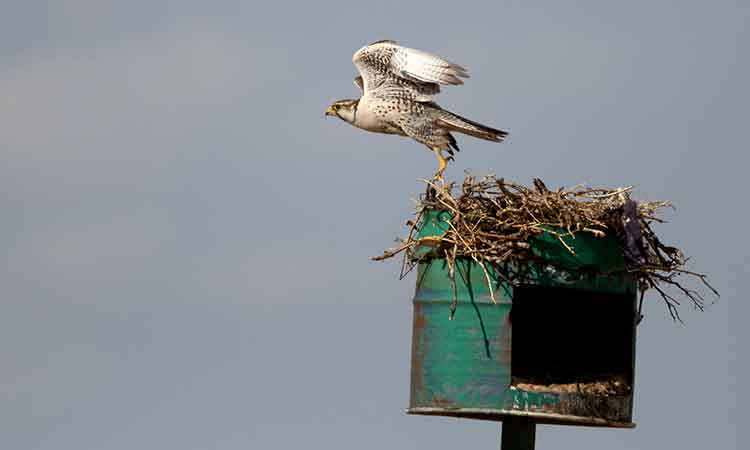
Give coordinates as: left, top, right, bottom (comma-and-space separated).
408, 212, 636, 427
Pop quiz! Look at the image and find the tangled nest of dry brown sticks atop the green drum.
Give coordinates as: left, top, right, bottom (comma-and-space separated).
373, 176, 719, 321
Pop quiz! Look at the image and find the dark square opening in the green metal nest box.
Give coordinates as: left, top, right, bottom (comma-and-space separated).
510, 285, 635, 393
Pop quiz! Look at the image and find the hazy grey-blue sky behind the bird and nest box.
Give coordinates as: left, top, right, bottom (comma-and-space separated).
0, 0, 750, 450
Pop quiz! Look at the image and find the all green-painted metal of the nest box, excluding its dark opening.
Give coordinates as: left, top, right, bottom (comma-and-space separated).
409, 211, 635, 427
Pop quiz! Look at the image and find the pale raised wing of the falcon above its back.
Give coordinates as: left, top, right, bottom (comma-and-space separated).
352, 41, 469, 96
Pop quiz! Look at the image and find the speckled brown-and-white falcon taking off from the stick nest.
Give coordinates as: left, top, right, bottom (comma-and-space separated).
326, 40, 508, 178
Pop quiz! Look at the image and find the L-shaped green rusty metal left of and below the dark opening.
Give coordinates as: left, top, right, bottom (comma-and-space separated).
407, 260, 635, 428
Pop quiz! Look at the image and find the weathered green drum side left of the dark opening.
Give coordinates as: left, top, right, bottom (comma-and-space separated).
410, 263, 510, 408
